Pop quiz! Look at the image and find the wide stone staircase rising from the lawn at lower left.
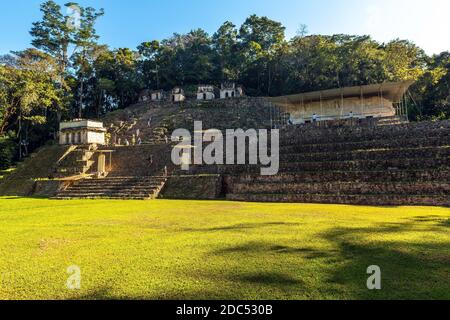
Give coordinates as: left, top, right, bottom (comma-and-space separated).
54, 177, 167, 200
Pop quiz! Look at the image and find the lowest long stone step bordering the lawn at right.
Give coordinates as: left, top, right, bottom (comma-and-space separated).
227, 194, 450, 206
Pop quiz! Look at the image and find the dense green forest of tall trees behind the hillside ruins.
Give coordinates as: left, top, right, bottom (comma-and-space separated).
0, 0, 450, 167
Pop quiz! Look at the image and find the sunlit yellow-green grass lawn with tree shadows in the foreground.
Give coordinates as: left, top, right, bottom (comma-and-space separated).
0, 198, 450, 299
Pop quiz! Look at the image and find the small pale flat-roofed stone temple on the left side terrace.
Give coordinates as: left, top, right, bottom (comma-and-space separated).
59, 119, 107, 145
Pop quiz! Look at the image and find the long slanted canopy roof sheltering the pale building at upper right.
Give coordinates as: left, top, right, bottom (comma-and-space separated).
269, 81, 414, 109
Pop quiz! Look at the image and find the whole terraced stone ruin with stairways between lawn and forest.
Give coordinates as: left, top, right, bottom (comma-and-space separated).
0, 90, 450, 206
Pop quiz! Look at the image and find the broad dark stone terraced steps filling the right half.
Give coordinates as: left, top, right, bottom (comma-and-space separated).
225, 121, 450, 206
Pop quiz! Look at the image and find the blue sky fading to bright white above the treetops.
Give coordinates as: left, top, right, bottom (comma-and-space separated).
0, 0, 450, 54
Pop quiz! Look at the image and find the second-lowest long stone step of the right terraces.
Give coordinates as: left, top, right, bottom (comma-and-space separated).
230, 181, 450, 197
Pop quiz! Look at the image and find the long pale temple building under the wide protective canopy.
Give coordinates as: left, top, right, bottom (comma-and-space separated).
270, 81, 413, 124
